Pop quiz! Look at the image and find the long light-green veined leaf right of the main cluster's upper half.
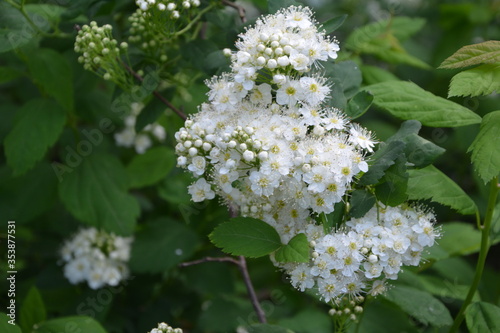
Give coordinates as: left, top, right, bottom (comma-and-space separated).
363, 81, 481, 127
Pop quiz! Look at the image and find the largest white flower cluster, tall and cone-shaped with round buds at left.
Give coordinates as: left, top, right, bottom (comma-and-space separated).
176, 7, 374, 242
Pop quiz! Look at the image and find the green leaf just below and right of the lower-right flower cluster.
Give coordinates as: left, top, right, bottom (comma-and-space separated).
385, 286, 453, 327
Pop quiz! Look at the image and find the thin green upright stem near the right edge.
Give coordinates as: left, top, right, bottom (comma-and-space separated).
450, 177, 499, 333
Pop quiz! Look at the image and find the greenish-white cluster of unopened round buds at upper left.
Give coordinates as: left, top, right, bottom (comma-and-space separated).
74, 21, 128, 84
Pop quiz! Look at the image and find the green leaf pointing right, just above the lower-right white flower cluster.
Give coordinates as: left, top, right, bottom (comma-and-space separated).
408, 165, 477, 215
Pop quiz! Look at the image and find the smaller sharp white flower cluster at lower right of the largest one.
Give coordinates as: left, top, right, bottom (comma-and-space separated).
284, 203, 439, 302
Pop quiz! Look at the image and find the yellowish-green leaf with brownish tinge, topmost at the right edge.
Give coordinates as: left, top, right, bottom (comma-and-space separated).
438, 40, 500, 68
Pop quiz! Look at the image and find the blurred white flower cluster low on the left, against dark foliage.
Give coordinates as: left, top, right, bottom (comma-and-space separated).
61, 228, 133, 289
